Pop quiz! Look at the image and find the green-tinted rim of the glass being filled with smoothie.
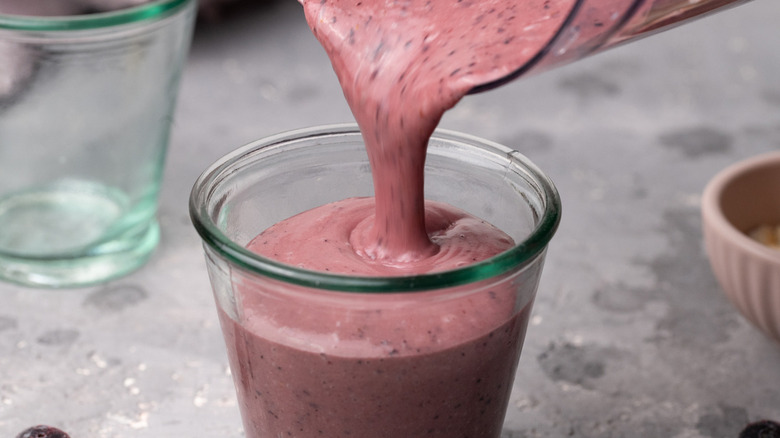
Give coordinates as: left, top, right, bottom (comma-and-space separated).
189, 124, 561, 293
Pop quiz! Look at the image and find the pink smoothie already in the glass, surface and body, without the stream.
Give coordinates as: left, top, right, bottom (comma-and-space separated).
220, 198, 536, 438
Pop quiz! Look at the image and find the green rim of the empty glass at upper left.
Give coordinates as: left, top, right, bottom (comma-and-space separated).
0, 0, 196, 32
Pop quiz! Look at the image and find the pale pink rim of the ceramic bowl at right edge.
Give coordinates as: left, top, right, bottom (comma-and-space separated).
701, 151, 780, 265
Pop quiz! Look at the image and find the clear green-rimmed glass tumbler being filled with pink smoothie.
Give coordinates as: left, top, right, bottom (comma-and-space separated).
190, 125, 561, 438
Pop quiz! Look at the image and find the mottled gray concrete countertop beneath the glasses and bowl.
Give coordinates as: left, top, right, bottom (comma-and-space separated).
0, 0, 780, 438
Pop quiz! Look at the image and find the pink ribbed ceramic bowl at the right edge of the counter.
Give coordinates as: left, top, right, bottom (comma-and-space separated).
702, 152, 780, 342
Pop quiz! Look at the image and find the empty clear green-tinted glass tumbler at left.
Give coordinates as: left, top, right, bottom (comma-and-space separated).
0, 0, 196, 287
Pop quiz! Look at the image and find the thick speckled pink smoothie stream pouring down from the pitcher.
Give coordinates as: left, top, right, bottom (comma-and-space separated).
303, 0, 572, 265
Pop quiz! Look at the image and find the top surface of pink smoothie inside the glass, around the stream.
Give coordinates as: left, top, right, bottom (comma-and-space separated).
247, 198, 514, 276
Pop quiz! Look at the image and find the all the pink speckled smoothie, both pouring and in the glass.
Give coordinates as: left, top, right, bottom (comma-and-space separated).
220, 0, 572, 438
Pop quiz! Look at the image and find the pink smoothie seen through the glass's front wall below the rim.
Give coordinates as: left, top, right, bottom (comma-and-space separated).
220, 268, 535, 438
